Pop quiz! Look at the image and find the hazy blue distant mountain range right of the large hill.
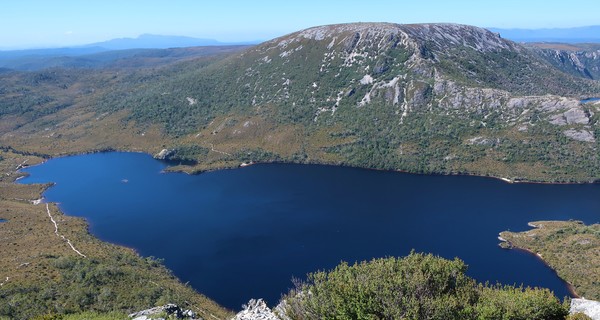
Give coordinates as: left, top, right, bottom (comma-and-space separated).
487, 26, 600, 43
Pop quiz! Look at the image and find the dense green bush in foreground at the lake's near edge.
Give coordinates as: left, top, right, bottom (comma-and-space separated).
284, 253, 568, 320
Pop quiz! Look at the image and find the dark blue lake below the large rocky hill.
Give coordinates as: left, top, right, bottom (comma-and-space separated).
20, 152, 600, 309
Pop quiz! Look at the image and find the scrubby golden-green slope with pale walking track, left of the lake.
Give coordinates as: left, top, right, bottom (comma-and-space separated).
0, 150, 230, 320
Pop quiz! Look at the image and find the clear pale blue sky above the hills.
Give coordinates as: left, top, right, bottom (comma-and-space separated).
0, 0, 600, 49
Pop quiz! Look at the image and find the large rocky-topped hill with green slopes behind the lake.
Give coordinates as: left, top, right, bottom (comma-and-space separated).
0, 23, 600, 181
